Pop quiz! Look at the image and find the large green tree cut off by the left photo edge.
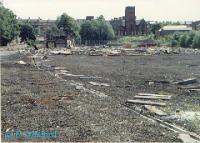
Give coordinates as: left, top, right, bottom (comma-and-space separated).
0, 3, 19, 46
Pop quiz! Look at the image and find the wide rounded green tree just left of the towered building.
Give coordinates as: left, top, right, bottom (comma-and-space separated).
80, 16, 115, 43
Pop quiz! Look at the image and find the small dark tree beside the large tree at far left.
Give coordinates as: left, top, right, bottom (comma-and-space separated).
19, 24, 36, 45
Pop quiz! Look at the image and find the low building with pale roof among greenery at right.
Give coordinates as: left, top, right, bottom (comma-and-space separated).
159, 25, 192, 35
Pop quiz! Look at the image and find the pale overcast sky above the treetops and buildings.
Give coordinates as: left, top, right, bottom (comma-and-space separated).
3, 0, 200, 21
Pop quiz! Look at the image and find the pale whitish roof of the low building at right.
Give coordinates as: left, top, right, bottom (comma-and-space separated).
160, 25, 192, 31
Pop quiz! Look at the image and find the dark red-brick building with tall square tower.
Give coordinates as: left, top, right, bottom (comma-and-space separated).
110, 6, 147, 36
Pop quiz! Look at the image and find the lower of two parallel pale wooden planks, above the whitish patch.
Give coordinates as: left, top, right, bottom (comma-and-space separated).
127, 100, 166, 106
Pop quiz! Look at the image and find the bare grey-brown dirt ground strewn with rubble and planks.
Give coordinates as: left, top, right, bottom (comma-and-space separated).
1, 49, 200, 142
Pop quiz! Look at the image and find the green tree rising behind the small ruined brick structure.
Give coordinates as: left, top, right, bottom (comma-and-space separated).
56, 13, 80, 39
